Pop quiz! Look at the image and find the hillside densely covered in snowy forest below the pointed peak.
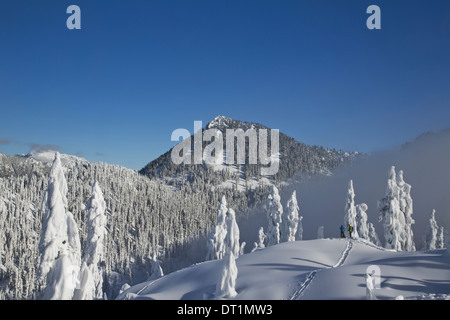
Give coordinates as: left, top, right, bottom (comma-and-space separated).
0, 154, 267, 299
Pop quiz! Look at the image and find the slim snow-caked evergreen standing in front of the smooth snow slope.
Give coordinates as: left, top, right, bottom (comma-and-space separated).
215, 208, 240, 298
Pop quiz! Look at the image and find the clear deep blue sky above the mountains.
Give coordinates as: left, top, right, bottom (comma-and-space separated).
0, 0, 450, 169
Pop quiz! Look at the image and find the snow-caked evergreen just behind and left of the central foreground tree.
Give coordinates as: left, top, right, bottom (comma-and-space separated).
206, 196, 228, 260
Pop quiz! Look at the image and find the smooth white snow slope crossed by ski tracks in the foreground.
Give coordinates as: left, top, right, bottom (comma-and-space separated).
118, 239, 450, 300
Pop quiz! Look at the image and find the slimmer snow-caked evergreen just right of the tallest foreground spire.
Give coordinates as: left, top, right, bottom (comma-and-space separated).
74, 181, 106, 300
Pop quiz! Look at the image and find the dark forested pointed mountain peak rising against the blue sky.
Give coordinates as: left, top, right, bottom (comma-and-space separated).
139, 116, 364, 185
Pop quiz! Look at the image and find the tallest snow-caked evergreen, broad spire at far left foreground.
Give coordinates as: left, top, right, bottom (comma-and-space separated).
39, 153, 81, 300
